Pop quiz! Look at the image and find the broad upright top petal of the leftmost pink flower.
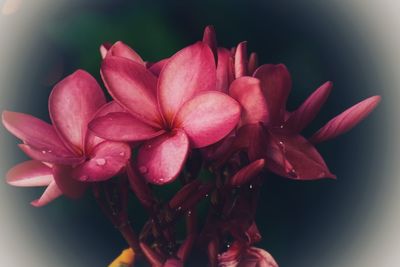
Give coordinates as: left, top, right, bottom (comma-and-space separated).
49, 70, 106, 153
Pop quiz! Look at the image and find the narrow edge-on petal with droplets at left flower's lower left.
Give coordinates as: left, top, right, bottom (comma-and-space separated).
18, 144, 84, 165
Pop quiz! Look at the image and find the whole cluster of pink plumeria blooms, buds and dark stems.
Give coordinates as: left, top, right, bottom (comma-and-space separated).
2, 26, 380, 266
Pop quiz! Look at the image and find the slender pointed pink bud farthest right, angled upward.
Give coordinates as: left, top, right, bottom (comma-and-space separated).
310, 96, 381, 143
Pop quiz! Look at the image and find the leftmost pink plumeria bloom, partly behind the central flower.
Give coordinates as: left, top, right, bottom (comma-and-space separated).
2, 70, 130, 206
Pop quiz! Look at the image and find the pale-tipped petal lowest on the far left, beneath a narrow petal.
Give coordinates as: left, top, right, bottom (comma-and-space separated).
6, 160, 53, 187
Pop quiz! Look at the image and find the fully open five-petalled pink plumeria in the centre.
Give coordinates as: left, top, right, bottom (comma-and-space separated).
90, 42, 240, 184
